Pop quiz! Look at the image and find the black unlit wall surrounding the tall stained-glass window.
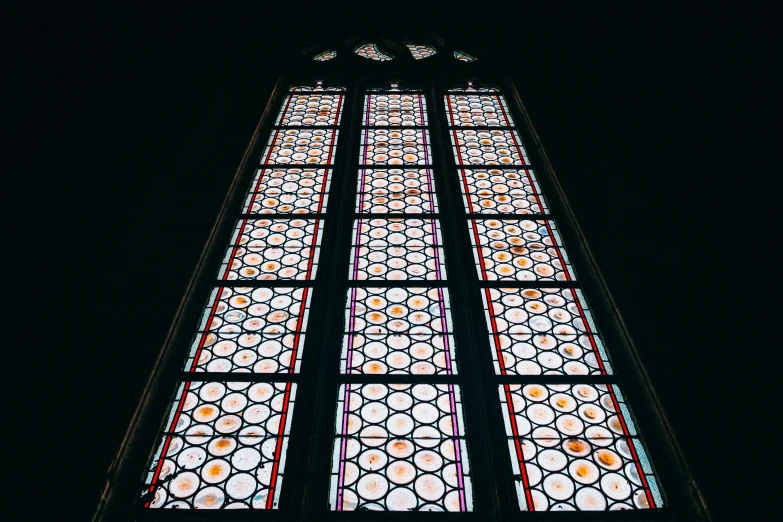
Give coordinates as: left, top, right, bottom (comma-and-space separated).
9, 0, 783, 521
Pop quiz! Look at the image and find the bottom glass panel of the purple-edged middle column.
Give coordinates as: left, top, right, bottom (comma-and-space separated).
329, 384, 473, 511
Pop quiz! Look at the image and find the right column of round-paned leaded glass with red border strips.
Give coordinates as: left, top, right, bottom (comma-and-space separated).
444, 84, 664, 511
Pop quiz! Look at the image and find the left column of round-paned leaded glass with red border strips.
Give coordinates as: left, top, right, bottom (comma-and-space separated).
142, 82, 344, 509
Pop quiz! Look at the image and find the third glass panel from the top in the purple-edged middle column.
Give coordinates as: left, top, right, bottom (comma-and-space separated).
356, 169, 438, 214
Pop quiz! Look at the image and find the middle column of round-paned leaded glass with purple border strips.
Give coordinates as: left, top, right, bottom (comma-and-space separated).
329, 85, 473, 512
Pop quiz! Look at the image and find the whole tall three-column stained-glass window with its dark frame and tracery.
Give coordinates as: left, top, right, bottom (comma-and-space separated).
96, 37, 708, 522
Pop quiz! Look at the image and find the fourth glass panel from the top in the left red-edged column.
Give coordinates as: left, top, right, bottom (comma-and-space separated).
218, 219, 323, 279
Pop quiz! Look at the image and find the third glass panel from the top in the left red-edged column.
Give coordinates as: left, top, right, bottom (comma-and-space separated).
243, 168, 331, 214
